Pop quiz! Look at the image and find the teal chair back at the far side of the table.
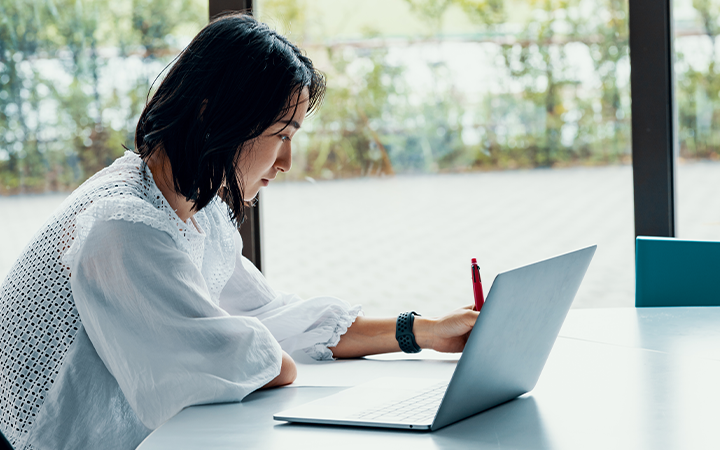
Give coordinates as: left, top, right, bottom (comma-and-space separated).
635, 236, 720, 308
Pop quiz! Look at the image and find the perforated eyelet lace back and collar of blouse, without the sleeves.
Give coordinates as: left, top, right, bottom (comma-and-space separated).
0, 152, 235, 449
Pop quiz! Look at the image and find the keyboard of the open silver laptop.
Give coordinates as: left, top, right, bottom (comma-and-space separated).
354, 383, 448, 423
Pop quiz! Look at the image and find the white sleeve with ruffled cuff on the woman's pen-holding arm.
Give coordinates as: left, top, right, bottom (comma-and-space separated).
220, 235, 362, 360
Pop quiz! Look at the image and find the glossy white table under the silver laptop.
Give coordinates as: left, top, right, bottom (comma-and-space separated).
139, 308, 720, 450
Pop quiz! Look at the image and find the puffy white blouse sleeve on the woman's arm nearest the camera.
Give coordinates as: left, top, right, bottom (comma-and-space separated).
63, 216, 281, 429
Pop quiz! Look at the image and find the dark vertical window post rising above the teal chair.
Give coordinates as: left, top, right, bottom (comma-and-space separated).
630, 0, 677, 237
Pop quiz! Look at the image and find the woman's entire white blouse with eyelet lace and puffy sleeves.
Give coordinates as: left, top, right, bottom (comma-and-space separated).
0, 152, 360, 449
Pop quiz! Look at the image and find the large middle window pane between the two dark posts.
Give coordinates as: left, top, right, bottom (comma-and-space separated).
256, 0, 634, 315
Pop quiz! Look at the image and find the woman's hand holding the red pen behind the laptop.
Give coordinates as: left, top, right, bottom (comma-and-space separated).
413, 306, 480, 353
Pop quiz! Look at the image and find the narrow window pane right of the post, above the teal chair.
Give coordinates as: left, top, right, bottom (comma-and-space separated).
673, 0, 720, 240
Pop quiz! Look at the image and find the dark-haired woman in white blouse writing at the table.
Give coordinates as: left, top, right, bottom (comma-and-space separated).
0, 14, 477, 449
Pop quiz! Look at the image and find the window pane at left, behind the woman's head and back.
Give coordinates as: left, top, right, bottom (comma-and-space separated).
0, 0, 208, 277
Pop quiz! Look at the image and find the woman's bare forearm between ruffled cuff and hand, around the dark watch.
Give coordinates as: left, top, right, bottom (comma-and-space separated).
330, 316, 433, 358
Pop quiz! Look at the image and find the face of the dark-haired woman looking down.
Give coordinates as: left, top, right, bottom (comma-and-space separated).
238, 87, 309, 201
